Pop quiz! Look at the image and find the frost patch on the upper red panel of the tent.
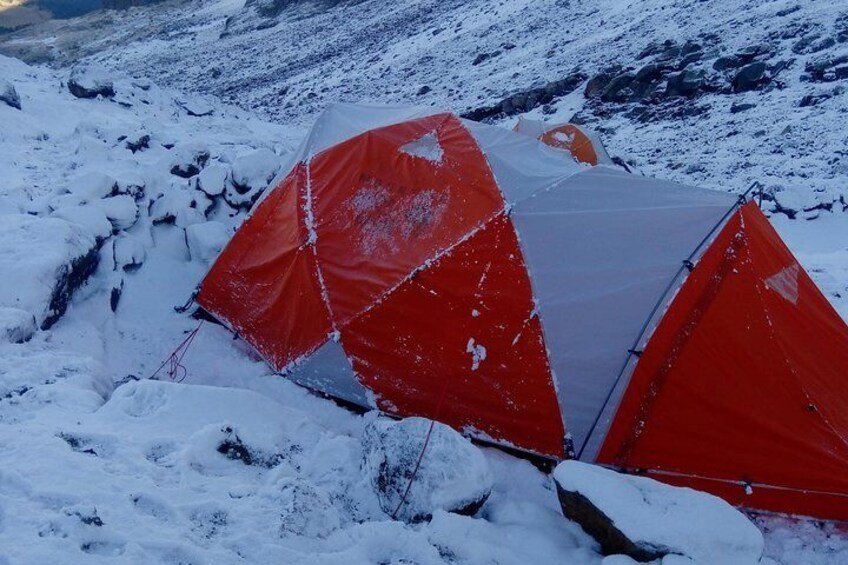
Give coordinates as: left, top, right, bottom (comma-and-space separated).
348, 177, 450, 256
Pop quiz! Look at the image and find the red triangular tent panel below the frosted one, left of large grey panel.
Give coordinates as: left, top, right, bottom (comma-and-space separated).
342, 215, 564, 457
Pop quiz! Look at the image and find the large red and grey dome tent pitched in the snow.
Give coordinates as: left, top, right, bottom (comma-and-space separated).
198, 105, 848, 519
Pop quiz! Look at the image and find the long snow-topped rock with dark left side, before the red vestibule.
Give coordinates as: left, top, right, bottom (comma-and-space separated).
553, 461, 764, 565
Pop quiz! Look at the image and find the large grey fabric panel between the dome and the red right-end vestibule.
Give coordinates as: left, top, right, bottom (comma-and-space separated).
512, 167, 736, 454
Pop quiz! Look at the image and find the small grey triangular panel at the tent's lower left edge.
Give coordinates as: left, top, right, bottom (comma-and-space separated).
286, 340, 374, 408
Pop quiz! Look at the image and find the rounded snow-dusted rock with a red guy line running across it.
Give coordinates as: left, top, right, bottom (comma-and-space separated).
362, 418, 492, 522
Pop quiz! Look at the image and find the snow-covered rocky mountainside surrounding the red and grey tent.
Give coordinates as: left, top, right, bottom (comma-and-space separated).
0, 0, 848, 565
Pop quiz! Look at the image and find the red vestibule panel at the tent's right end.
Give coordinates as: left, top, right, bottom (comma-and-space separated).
598, 203, 848, 519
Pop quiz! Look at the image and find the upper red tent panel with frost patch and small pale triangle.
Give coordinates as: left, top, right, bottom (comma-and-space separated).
310, 114, 504, 327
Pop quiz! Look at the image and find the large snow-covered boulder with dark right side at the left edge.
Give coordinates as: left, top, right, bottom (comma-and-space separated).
0, 215, 98, 329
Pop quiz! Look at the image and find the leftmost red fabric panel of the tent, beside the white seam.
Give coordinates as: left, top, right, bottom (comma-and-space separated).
197, 165, 332, 370
